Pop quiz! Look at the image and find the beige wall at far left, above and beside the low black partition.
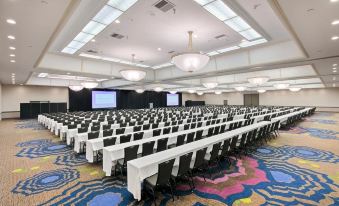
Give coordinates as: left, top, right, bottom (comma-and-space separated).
1, 85, 69, 118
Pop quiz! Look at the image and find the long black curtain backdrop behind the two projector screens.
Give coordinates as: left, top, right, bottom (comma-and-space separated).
68, 89, 182, 112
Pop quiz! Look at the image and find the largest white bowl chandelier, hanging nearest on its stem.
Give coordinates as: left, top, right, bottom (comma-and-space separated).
172, 31, 210, 72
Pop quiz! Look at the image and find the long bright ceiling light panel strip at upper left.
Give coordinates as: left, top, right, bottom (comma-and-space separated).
61, 0, 137, 54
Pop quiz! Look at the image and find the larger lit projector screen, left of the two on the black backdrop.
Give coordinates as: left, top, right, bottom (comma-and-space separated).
92, 91, 117, 109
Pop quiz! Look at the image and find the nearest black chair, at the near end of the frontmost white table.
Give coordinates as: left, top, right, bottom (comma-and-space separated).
143, 159, 175, 205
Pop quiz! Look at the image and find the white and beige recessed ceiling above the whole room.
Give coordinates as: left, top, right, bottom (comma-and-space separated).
0, 0, 339, 91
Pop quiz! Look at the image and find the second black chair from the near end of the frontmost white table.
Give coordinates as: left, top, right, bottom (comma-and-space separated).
172, 152, 194, 190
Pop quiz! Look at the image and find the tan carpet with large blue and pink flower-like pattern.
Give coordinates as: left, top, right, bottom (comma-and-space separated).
0, 113, 339, 206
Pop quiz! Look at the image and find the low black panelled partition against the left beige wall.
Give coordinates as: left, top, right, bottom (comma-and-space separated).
20, 101, 67, 119
